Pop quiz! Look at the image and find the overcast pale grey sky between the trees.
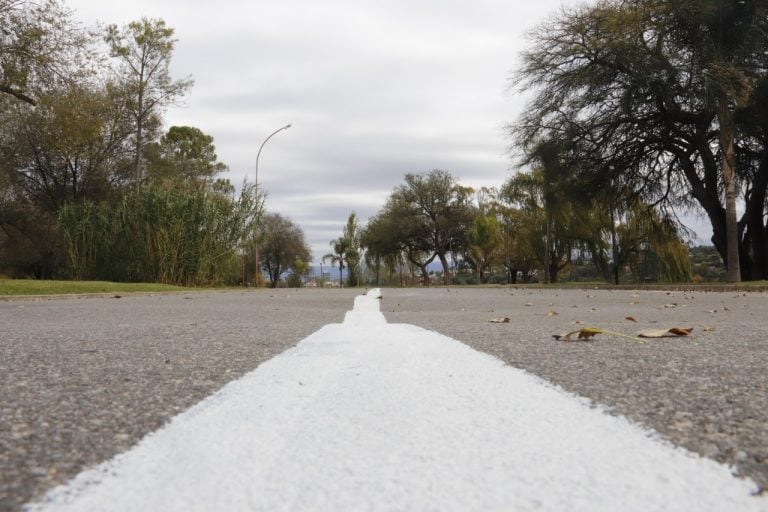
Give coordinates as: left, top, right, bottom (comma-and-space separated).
65, 0, 712, 262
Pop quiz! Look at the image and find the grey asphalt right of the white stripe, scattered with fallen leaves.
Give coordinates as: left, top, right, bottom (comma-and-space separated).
382, 288, 768, 492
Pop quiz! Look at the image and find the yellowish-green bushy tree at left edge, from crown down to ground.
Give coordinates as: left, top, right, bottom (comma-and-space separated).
0, 85, 130, 278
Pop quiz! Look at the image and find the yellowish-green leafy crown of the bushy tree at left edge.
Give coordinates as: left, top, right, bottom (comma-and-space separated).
0, 85, 130, 213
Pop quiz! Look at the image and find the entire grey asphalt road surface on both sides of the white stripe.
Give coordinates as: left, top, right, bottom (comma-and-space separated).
0, 288, 768, 511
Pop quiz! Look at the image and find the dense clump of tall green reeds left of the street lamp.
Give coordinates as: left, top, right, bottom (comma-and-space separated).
59, 186, 262, 286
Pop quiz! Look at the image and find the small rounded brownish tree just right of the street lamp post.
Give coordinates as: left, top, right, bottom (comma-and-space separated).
259, 213, 311, 288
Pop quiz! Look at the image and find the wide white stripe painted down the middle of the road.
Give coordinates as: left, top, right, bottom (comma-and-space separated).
27, 290, 768, 512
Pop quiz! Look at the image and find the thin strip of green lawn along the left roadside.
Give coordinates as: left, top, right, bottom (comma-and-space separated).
0, 279, 190, 297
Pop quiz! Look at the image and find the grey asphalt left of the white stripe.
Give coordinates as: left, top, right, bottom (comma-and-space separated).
0, 290, 360, 511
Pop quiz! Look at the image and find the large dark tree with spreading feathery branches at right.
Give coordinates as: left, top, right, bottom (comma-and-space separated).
513, 0, 768, 280
